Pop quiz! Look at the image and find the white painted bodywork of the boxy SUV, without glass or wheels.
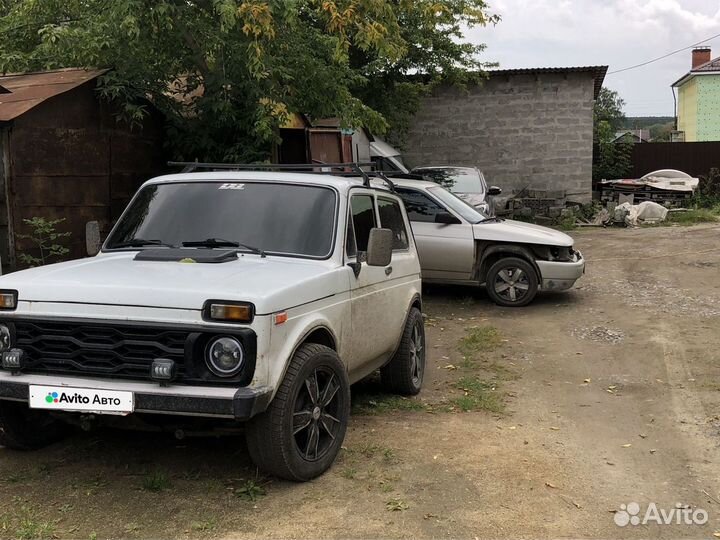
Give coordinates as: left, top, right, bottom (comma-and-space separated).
0, 171, 421, 476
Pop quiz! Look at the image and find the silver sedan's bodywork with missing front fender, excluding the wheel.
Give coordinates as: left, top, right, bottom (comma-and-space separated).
394, 178, 585, 305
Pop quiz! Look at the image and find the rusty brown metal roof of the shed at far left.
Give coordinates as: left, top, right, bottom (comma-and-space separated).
0, 68, 108, 122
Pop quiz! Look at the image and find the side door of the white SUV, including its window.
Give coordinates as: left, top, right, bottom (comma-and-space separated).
345, 189, 400, 382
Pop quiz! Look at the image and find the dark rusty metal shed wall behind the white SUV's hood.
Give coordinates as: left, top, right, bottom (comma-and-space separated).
8, 81, 166, 263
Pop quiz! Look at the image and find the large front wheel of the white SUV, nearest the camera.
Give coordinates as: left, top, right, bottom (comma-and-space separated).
246, 343, 350, 482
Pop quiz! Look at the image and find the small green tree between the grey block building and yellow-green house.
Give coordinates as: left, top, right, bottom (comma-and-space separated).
593, 87, 633, 183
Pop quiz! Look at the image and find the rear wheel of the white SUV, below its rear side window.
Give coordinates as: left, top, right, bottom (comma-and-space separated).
380, 307, 425, 396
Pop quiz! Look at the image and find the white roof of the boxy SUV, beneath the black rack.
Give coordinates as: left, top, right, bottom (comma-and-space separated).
143, 171, 394, 191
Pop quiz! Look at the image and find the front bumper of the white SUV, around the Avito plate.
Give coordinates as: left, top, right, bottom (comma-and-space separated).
0, 371, 272, 420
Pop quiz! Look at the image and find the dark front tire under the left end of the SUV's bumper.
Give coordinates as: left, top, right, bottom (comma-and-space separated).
0, 401, 70, 450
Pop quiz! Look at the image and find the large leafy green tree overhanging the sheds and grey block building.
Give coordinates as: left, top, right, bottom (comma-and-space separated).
0, 0, 498, 161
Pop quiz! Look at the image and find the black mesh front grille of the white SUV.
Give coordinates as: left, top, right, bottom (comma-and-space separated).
14, 321, 190, 380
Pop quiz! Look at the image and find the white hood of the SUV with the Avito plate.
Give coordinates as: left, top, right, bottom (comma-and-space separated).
0, 252, 347, 315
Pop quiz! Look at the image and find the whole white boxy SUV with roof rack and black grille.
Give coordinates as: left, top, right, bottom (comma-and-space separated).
0, 171, 425, 480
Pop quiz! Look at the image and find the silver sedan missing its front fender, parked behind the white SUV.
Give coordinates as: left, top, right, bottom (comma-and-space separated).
394, 179, 585, 307
